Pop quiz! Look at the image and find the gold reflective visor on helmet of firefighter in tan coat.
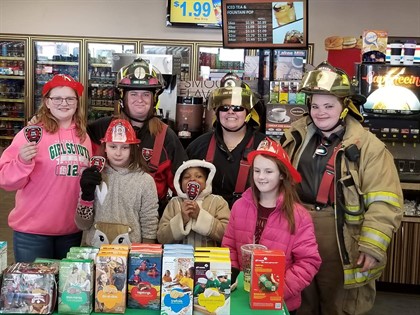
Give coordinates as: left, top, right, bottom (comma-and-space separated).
300, 69, 351, 97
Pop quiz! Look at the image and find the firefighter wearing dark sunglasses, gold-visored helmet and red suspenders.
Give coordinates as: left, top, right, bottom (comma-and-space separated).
186, 73, 265, 207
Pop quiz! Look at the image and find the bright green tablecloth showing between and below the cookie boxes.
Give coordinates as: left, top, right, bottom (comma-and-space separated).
54, 272, 289, 315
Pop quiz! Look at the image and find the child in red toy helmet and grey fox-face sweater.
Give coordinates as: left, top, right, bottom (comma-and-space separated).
75, 119, 158, 247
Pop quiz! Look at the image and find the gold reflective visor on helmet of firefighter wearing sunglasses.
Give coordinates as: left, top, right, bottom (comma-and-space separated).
207, 87, 258, 112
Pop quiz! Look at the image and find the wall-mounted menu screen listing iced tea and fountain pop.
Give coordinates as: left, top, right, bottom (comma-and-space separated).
222, 0, 308, 49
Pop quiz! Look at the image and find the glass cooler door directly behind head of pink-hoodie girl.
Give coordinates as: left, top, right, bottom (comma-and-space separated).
33, 39, 81, 113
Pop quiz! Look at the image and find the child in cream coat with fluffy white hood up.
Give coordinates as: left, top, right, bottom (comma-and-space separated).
157, 160, 230, 246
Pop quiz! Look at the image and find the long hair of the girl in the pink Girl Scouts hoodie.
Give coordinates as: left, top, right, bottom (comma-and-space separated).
36, 89, 87, 142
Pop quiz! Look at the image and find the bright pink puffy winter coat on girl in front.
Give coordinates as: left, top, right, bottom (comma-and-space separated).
222, 188, 321, 311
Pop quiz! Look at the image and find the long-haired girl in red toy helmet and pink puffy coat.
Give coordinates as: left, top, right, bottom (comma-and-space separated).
222, 138, 321, 314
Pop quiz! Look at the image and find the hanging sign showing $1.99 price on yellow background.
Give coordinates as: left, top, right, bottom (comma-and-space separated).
170, 0, 221, 24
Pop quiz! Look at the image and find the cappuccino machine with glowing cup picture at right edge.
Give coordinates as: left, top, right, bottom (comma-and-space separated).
356, 63, 420, 183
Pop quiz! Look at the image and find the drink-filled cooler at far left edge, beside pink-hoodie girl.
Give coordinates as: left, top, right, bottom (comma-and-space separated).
0, 36, 28, 154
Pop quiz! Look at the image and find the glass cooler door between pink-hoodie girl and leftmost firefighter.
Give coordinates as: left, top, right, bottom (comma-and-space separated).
86, 42, 137, 120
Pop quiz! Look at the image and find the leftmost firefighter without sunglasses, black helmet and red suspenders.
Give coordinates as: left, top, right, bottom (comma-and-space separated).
88, 59, 187, 215
